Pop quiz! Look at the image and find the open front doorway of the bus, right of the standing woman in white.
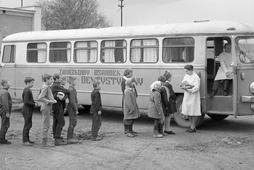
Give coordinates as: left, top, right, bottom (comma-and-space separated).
206, 36, 233, 119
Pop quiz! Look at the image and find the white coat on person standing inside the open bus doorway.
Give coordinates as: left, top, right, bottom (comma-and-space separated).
215, 52, 233, 80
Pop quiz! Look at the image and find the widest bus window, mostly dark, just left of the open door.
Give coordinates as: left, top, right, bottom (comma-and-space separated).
162, 38, 194, 63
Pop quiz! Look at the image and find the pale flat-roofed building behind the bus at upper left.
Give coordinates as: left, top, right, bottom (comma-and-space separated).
0, 6, 41, 45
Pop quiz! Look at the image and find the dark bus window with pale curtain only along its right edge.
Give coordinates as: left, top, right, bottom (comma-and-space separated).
49, 42, 71, 63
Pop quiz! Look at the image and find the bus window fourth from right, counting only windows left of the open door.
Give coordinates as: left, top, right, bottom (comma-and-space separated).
101, 40, 127, 63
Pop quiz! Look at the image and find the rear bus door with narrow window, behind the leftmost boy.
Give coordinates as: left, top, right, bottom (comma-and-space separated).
1, 45, 16, 97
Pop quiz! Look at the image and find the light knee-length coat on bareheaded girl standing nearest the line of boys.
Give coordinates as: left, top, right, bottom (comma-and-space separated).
124, 87, 139, 120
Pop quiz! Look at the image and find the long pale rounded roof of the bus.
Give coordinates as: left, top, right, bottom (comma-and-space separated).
3, 21, 254, 42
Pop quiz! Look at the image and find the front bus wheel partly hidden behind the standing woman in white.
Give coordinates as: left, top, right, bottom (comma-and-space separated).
174, 95, 205, 128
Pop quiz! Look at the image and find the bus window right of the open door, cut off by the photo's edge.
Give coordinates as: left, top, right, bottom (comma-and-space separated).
236, 37, 254, 64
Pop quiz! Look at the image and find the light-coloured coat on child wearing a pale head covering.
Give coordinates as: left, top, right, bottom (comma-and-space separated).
148, 90, 163, 119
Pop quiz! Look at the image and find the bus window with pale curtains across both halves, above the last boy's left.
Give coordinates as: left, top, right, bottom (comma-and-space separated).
74, 41, 98, 63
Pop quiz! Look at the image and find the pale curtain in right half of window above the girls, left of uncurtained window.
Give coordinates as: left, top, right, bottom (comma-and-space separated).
143, 40, 157, 63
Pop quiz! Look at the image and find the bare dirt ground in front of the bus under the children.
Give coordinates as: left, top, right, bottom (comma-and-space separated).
0, 111, 254, 170
